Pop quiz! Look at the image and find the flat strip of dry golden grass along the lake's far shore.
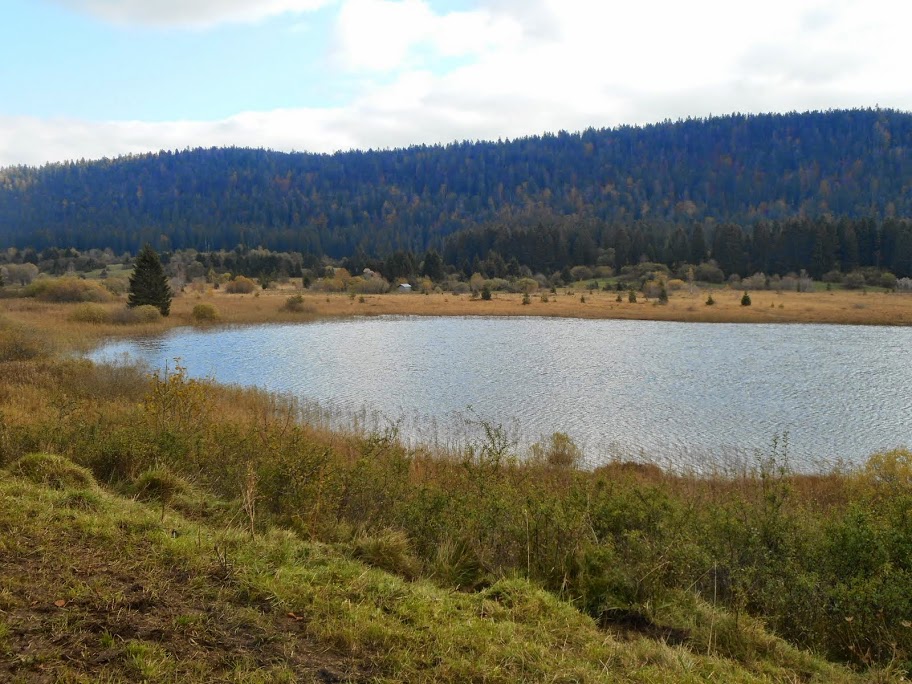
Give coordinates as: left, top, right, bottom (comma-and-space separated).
0, 289, 912, 356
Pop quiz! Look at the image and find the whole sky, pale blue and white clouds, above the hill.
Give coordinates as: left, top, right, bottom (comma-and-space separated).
0, 0, 912, 167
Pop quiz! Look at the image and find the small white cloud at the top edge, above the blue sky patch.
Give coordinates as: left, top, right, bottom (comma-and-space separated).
50, 0, 334, 27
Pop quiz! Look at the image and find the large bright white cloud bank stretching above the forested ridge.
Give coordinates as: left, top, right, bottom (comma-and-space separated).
0, 0, 912, 165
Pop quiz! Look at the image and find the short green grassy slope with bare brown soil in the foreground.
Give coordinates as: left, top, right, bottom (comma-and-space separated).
0, 454, 874, 682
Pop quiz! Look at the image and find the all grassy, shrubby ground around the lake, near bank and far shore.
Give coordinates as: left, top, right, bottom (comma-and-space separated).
0, 282, 912, 682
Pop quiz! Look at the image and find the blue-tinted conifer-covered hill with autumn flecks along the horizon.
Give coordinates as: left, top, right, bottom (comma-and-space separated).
0, 110, 912, 257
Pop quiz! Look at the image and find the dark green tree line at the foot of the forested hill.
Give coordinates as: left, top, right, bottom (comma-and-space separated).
7, 217, 912, 283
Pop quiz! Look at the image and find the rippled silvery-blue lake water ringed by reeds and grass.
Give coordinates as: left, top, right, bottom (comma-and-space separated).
92, 317, 912, 469
